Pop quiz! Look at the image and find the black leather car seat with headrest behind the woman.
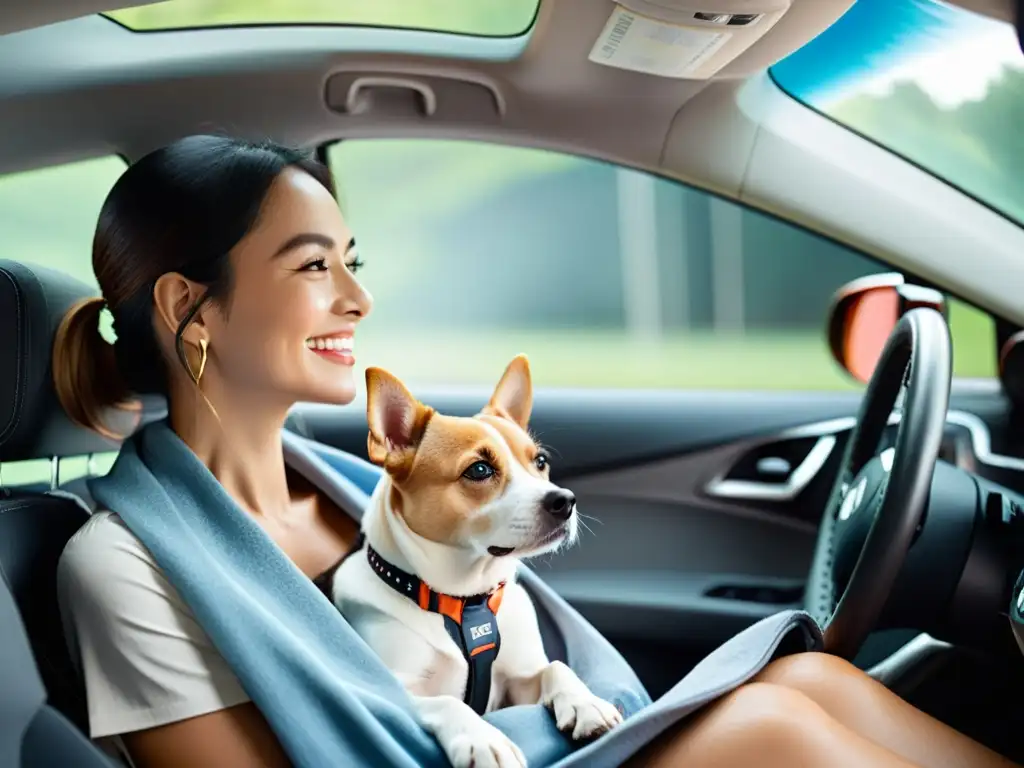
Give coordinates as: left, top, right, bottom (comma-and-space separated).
0, 260, 117, 768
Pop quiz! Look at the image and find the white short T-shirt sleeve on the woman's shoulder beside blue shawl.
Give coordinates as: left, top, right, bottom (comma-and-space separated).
57, 512, 250, 764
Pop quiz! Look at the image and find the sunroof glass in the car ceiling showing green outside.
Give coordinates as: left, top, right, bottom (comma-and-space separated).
105, 0, 540, 37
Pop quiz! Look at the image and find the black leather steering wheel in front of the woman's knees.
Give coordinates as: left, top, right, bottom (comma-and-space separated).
804, 308, 952, 659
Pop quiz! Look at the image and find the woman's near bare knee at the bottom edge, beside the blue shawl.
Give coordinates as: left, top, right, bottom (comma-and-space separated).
626, 683, 914, 768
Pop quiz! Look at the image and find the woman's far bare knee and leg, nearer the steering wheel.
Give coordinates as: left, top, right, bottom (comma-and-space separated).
757, 653, 1016, 768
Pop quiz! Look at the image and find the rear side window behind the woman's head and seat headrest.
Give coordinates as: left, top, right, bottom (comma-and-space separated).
0, 157, 125, 485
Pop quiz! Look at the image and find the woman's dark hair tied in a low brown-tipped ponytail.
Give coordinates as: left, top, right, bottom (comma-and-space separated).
53, 135, 335, 436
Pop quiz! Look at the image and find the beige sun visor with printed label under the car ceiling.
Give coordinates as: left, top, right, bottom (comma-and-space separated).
589, 0, 791, 80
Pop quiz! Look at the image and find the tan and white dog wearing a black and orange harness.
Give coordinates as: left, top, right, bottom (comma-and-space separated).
331, 355, 623, 768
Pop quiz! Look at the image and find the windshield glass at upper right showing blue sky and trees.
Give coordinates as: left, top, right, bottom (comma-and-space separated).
771, 0, 1024, 227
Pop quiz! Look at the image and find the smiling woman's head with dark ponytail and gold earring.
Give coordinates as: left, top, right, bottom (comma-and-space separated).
46, 136, 372, 442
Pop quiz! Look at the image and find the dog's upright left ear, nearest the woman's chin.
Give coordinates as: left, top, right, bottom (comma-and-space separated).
367, 368, 433, 469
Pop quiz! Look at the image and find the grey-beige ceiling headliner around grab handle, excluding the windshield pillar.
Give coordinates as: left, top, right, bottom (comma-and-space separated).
0, 0, 852, 172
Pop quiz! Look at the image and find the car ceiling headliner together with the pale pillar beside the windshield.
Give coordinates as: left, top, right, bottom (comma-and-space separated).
8, 0, 1024, 325
